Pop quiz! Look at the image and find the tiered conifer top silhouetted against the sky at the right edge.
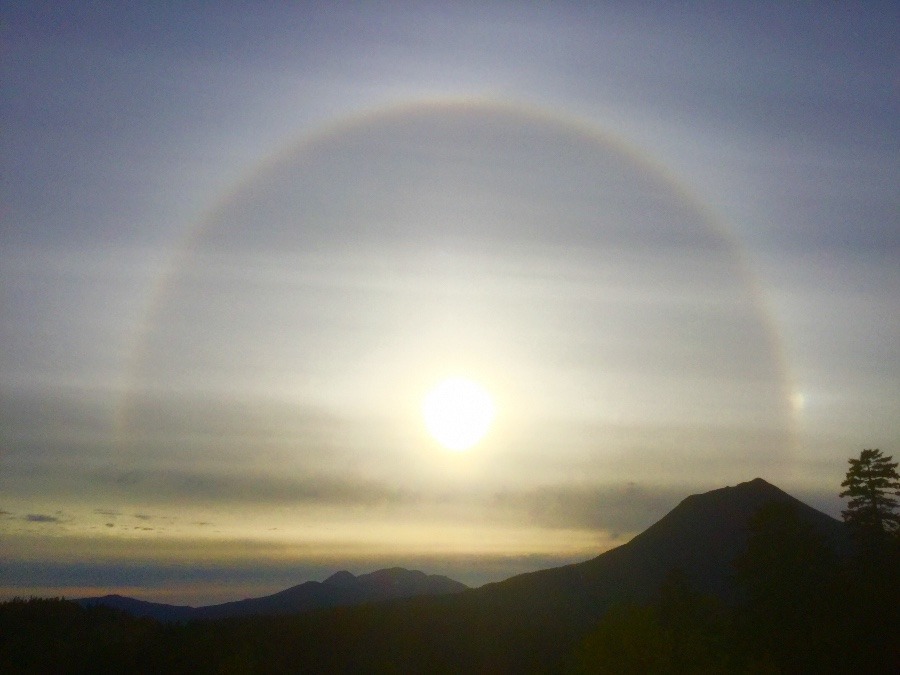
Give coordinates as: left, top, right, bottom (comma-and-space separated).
840, 450, 900, 543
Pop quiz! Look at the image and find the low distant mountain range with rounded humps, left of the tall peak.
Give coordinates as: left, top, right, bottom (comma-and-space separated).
77, 567, 468, 621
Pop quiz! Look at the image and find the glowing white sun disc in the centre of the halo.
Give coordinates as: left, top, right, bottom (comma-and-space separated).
422, 377, 496, 452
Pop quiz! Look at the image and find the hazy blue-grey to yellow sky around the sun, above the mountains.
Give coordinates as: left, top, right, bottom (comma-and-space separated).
0, 1, 900, 603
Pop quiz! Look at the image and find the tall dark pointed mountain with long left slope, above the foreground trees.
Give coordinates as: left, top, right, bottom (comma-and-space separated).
436, 478, 848, 670
